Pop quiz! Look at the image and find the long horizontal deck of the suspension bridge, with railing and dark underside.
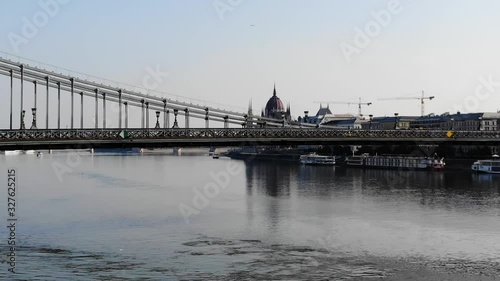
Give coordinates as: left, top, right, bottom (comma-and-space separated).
0, 128, 500, 150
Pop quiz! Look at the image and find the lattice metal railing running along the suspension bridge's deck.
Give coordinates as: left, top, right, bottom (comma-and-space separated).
0, 128, 500, 142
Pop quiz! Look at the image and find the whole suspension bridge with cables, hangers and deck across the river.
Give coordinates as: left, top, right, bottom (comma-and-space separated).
0, 57, 500, 150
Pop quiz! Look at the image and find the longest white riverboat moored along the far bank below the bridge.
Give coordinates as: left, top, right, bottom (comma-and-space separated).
346, 154, 446, 170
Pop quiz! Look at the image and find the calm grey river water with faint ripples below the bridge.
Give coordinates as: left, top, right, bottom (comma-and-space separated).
0, 153, 500, 280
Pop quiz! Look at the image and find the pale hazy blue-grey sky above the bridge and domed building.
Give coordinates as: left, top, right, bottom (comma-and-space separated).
0, 0, 500, 127
